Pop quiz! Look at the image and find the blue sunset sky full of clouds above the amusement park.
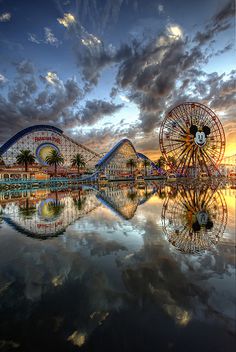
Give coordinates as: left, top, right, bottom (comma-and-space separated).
0, 0, 236, 160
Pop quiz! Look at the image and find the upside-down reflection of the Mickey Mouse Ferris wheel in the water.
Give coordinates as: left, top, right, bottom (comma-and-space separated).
162, 185, 227, 253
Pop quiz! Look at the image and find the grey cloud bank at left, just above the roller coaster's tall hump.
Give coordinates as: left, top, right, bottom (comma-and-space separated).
0, 67, 82, 142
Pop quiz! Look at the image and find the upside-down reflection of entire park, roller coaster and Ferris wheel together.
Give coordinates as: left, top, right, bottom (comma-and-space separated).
0, 182, 230, 253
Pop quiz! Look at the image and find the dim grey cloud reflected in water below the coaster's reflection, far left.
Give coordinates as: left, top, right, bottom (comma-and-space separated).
0, 231, 73, 300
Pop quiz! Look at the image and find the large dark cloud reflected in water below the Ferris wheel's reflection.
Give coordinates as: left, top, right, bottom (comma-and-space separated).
121, 222, 235, 331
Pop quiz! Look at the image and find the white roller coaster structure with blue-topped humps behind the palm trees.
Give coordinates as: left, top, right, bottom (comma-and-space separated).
0, 125, 155, 177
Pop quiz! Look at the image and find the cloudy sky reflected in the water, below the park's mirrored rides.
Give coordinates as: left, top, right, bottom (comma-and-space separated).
0, 184, 234, 350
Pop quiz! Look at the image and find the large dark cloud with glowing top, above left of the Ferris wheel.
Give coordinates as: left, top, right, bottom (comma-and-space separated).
113, 33, 191, 133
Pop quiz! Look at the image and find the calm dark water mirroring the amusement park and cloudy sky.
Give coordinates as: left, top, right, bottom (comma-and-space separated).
0, 182, 236, 352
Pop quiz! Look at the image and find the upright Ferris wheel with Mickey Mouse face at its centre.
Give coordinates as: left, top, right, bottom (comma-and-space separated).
160, 103, 225, 175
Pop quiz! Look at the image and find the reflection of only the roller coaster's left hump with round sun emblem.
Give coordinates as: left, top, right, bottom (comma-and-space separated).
3, 190, 100, 239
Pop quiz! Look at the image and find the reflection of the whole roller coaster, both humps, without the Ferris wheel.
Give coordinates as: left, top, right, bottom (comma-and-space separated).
0, 185, 158, 239
